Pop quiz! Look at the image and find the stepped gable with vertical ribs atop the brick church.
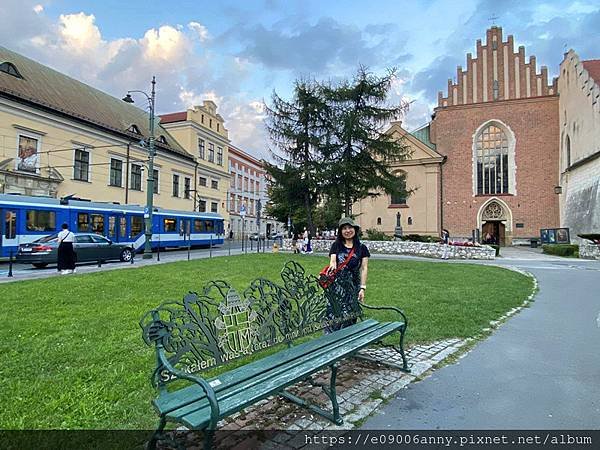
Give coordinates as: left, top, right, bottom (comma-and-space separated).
438, 26, 557, 107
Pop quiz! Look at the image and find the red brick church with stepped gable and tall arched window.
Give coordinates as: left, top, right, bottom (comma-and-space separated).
430, 26, 560, 245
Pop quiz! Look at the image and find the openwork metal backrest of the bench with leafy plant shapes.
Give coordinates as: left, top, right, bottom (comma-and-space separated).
140, 261, 362, 384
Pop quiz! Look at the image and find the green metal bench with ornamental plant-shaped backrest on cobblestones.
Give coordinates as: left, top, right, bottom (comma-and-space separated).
140, 262, 408, 448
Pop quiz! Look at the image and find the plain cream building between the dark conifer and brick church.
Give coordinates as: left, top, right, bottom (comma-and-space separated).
352, 122, 444, 236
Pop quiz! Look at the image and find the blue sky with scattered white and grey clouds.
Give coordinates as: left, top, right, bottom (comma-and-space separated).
0, 0, 600, 158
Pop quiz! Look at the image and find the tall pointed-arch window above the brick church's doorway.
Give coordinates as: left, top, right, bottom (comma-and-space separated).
475, 125, 510, 195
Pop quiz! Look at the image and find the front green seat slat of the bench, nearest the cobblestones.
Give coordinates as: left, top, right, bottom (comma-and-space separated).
168, 322, 404, 428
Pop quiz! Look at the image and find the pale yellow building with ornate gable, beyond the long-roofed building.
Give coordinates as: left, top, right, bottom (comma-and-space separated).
160, 100, 230, 221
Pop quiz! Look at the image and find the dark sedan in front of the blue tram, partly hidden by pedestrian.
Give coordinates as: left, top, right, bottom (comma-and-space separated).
16, 233, 134, 268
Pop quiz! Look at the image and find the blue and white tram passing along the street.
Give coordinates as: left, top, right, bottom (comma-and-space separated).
0, 194, 224, 258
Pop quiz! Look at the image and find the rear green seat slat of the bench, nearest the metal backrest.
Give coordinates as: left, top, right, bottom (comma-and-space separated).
153, 319, 379, 413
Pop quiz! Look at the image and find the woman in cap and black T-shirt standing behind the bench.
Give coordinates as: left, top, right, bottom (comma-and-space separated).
327, 217, 371, 331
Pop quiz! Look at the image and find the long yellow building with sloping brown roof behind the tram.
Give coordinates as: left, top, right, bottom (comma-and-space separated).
0, 47, 196, 210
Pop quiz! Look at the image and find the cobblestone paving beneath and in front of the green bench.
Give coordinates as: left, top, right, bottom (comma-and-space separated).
158, 339, 469, 449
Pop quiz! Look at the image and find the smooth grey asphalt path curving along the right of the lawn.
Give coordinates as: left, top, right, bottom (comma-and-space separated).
363, 259, 600, 430
